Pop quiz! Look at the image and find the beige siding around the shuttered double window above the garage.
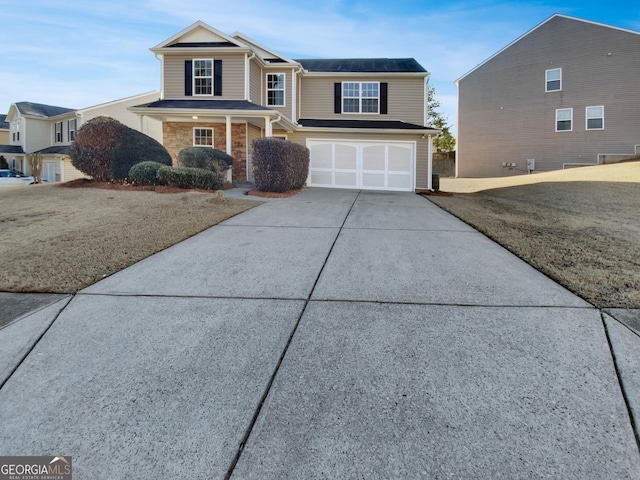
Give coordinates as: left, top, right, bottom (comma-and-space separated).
299, 75, 424, 125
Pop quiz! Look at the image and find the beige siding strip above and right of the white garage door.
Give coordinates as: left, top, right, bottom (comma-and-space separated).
287, 132, 429, 189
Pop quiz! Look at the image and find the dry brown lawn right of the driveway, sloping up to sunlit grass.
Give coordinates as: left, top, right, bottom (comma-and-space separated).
428, 162, 640, 308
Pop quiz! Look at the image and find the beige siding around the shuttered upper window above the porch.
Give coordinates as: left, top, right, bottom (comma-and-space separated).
164, 53, 245, 100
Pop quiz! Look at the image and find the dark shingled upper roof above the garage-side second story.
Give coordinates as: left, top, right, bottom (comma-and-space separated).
296, 58, 427, 73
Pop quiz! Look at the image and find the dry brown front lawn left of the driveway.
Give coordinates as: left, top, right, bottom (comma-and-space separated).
0, 184, 260, 293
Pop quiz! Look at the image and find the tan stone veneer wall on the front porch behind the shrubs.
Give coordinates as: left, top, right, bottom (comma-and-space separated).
162, 122, 247, 182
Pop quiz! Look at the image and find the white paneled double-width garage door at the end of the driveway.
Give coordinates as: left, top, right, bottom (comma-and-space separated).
307, 140, 416, 192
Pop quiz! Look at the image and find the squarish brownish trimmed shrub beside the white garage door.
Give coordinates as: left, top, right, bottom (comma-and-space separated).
251, 138, 309, 192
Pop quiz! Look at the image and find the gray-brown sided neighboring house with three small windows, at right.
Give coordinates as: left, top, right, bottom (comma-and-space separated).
456, 15, 640, 177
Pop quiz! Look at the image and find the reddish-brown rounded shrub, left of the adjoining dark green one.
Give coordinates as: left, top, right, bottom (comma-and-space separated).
69, 117, 126, 181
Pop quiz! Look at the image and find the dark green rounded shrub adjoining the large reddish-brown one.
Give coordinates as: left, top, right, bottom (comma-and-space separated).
109, 126, 171, 180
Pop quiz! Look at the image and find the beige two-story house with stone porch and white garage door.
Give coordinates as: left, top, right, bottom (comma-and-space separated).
131, 22, 439, 191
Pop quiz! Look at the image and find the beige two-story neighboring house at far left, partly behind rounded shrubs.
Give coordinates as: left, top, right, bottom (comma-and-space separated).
0, 91, 162, 182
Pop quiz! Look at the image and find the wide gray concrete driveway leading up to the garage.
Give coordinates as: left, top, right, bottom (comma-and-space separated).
0, 189, 640, 479
